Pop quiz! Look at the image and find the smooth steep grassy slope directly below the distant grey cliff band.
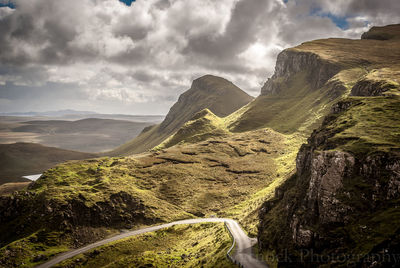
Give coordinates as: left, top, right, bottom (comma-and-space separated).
227, 73, 338, 134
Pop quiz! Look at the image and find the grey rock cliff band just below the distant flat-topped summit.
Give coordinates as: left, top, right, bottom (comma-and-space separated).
261, 49, 340, 95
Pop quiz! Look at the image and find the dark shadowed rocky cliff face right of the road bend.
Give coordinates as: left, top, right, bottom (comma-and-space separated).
259, 98, 400, 266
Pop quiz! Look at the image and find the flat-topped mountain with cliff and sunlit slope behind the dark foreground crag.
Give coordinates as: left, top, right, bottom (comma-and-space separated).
229, 25, 400, 135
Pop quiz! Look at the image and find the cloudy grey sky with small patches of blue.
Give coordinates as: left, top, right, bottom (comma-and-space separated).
0, 0, 400, 114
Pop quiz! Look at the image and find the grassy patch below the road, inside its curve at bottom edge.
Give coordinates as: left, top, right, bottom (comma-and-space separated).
56, 224, 235, 267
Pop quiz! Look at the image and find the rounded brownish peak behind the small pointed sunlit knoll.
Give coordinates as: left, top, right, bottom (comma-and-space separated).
109, 75, 253, 155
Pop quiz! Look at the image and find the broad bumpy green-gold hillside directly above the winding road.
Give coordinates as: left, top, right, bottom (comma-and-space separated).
0, 129, 300, 265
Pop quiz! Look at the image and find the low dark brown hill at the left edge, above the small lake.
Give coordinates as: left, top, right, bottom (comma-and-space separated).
0, 143, 95, 184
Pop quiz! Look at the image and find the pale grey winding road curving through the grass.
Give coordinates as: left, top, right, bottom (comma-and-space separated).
36, 218, 268, 268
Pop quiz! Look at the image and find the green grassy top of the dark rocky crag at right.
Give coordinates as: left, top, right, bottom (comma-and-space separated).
326, 96, 400, 155
